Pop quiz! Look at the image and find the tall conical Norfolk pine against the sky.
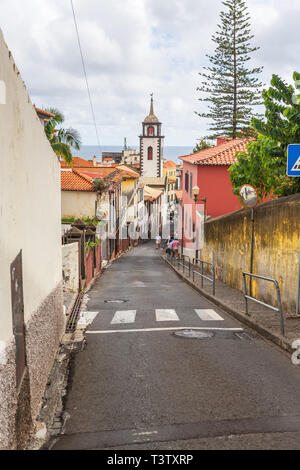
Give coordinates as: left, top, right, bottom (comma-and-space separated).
196, 0, 262, 138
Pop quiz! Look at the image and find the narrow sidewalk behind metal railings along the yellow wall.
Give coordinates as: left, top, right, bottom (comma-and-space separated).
162, 255, 300, 353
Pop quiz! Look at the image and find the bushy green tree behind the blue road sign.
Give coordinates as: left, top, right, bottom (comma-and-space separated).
229, 72, 300, 200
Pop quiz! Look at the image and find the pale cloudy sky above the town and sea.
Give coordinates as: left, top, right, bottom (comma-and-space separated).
0, 0, 300, 146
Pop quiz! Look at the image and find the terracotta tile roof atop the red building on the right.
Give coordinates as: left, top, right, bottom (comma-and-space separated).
179, 138, 254, 165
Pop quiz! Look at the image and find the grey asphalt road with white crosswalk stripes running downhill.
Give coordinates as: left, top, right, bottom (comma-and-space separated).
53, 244, 300, 450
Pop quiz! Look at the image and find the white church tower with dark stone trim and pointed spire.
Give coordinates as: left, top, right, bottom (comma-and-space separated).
140, 94, 164, 178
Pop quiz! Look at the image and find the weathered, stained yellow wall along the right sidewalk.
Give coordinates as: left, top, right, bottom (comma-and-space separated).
201, 194, 300, 313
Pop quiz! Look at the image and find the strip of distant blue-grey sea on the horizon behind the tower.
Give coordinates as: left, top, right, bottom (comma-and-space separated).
73, 145, 193, 162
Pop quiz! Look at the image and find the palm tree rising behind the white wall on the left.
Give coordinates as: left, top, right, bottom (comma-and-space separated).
45, 108, 81, 165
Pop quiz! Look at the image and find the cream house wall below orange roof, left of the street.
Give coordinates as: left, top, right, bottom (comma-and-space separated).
61, 191, 97, 219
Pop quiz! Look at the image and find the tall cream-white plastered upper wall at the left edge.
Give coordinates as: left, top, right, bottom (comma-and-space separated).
0, 30, 62, 341
